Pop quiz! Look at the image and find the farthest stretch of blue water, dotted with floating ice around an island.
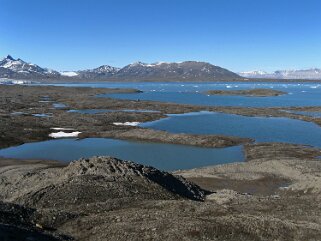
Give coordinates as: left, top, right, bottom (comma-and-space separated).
45, 82, 321, 107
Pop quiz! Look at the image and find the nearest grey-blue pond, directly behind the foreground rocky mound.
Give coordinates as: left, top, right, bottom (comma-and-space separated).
0, 138, 244, 171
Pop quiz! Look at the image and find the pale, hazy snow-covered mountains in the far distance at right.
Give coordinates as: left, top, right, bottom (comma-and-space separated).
238, 68, 321, 79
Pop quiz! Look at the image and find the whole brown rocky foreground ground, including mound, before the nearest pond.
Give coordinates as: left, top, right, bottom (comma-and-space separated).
0, 143, 321, 241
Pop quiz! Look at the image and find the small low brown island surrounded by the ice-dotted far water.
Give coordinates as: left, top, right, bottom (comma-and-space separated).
205, 89, 287, 97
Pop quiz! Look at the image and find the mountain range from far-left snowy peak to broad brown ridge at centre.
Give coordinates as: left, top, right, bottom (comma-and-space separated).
0, 55, 241, 81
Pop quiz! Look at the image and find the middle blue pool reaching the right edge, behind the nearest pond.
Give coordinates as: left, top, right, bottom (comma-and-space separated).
140, 112, 321, 147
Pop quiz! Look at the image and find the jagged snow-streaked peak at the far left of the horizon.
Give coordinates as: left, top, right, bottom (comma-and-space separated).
0, 55, 60, 79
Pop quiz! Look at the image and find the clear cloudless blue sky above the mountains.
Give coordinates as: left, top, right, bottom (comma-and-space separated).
0, 0, 321, 71
